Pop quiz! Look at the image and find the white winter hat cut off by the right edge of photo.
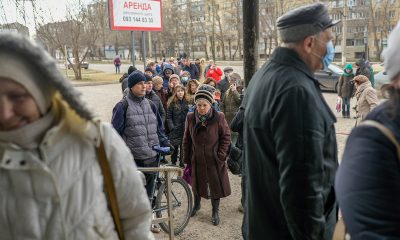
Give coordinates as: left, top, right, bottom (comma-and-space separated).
382, 22, 400, 80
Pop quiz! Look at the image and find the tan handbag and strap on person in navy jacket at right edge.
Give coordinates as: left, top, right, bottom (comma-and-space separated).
332, 120, 400, 240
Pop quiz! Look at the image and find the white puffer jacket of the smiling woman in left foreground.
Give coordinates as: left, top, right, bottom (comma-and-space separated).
0, 121, 154, 240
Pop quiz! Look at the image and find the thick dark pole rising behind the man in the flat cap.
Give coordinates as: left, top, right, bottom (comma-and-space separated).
243, 0, 259, 87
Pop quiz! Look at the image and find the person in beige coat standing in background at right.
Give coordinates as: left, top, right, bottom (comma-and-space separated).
353, 75, 379, 123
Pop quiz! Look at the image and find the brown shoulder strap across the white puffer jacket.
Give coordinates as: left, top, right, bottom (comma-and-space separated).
96, 140, 125, 240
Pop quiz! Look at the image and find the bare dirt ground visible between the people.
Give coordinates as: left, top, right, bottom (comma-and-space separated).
78, 84, 362, 240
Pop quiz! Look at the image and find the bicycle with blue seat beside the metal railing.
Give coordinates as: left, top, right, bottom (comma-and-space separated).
145, 147, 193, 235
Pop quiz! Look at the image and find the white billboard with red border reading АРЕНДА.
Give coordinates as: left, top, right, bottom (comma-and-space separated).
109, 0, 162, 31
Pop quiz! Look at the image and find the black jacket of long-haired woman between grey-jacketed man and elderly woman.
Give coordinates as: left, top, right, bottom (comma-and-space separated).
167, 99, 189, 146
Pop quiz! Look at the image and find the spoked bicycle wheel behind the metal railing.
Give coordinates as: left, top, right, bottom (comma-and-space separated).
154, 177, 193, 235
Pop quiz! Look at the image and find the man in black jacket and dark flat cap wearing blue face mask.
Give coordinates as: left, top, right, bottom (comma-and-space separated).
242, 3, 338, 240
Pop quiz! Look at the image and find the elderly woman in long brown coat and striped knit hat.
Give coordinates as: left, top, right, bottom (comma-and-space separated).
182, 90, 231, 226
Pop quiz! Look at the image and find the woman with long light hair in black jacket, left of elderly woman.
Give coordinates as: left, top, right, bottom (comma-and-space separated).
167, 85, 189, 167
